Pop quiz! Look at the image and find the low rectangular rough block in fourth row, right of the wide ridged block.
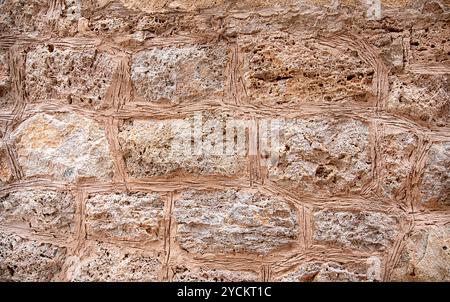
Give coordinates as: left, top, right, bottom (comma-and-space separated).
313, 210, 399, 251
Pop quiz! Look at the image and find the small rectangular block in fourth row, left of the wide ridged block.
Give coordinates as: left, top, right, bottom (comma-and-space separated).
86, 193, 164, 241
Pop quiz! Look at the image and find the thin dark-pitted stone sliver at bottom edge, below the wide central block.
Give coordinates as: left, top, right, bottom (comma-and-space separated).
172, 265, 260, 282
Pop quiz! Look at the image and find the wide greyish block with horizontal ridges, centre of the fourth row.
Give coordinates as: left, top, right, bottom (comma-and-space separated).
174, 189, 299, 254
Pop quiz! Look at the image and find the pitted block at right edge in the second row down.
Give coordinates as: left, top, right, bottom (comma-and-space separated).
386, 74, 450, 127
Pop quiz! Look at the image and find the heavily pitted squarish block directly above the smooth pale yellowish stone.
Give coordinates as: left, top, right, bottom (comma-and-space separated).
25, 44, 117, 108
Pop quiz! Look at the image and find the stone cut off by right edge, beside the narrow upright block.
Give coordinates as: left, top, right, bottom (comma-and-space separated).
420, 142, 450, 206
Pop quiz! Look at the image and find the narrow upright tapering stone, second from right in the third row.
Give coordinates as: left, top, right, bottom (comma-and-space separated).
380, 127, 418, 200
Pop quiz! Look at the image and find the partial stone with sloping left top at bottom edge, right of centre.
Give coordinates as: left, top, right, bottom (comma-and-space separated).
274, 257, 381, 282
